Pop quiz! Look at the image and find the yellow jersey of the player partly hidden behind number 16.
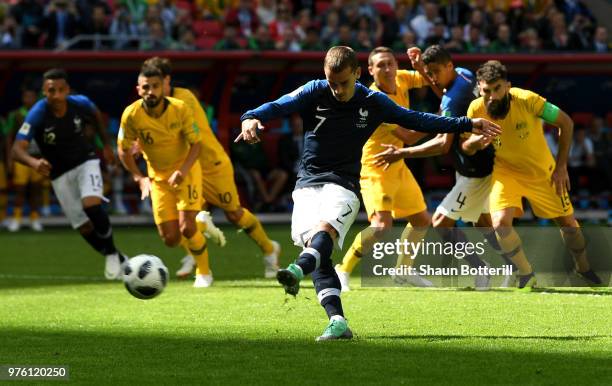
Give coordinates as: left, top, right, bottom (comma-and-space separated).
172, 87, 230, 169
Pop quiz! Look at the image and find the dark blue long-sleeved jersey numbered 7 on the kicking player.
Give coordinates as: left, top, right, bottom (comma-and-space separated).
241, 80, 472, 192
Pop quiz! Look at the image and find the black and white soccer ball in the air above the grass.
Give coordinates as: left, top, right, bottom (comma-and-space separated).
123, 255, 168, 299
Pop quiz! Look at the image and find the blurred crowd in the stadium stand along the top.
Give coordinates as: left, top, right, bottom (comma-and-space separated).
0, 0, 612, 53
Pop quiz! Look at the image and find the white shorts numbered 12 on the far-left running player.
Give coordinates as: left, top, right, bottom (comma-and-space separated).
51, 159, 108, 229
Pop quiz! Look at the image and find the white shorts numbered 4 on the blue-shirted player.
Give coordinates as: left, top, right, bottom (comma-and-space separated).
436, 173, 493, 223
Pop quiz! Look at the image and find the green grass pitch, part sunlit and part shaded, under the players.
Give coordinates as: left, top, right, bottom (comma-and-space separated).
0, 225, 612, 385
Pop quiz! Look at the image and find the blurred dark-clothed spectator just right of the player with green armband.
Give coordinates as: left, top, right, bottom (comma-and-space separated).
567, 128, 595, 190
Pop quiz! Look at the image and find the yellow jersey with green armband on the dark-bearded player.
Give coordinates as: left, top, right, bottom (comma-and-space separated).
467, 87, 555, 179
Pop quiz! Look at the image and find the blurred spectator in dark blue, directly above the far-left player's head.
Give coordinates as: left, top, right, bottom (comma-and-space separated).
42, 0, 80, 48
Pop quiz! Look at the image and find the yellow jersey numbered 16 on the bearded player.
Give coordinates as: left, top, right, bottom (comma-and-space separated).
117, 97, 201, 180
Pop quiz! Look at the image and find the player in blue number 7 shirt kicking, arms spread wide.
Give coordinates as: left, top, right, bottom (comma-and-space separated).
236, 46, 501, 340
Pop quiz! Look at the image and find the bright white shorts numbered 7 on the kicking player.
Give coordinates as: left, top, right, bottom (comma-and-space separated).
291, 184, 359, 249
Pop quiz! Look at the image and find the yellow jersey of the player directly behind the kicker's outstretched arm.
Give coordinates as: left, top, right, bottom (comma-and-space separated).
361, 70, 427, 175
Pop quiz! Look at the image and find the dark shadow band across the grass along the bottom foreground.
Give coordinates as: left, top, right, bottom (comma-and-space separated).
0, 326, 612, 385
